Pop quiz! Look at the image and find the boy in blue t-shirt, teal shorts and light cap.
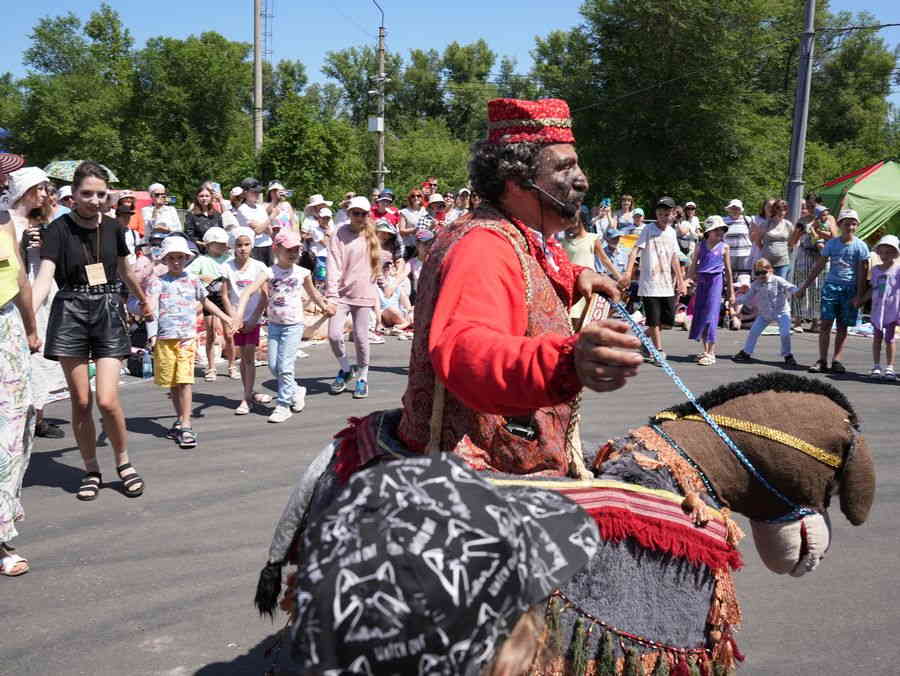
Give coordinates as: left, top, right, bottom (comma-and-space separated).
797, 209, 869, 373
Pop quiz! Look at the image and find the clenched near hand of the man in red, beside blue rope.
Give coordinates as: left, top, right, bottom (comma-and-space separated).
574, 319, 644, 392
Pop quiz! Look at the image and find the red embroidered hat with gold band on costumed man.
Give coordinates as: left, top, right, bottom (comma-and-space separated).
488, 99, 575, 144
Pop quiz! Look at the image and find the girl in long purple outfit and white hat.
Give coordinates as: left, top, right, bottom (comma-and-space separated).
688, 216, 734, 366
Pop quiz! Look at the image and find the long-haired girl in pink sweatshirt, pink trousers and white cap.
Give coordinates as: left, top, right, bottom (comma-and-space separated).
325, 197, 381, 399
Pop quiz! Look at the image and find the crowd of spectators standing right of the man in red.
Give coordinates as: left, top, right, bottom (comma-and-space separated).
562, 194, 900, 380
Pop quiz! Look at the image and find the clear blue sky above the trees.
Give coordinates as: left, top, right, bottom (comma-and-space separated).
7, 0, 900, 105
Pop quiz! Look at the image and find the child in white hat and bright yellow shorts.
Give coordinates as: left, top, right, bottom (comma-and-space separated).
147, 236, 231, 448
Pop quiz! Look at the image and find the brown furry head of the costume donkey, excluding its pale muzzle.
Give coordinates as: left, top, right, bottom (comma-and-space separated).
662, 373, 875, 525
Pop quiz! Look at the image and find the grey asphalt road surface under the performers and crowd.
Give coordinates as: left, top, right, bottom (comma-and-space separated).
7, 331, 900, 676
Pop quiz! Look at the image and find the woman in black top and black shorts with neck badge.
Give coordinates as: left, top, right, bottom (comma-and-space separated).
34, 162, 150, 500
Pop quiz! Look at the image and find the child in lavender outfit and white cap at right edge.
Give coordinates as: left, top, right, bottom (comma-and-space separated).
858, 235, 900, 380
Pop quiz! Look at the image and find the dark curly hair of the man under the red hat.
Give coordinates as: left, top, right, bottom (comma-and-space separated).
469, 140, 546, 204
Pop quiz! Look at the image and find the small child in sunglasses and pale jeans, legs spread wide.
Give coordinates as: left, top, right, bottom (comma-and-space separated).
733, 258, 797, 368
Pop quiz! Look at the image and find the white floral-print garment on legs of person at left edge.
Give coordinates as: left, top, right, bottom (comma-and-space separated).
0, 301, 35, 543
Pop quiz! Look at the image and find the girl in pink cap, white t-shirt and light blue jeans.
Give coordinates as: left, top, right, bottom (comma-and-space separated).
235, 228, 335, 423
